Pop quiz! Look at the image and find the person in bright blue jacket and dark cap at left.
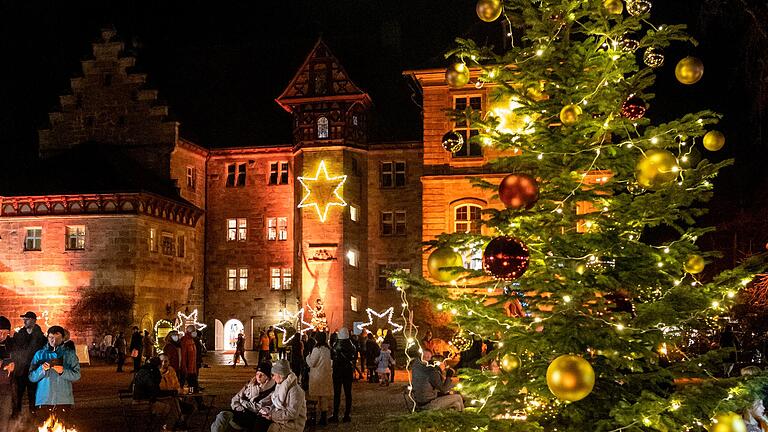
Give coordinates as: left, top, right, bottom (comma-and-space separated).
29, 326, 80, 418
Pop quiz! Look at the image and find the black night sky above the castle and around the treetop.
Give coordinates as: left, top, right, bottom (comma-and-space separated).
0, 0, 768, 224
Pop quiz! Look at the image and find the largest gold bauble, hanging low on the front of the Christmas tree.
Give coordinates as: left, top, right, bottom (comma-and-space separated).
547, 355, 595, 402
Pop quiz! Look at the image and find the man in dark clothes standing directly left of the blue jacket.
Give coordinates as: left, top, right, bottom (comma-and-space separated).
11, 311, 46, 417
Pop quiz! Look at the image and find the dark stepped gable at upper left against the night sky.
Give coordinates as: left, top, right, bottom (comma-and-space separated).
39, 29, 178, 158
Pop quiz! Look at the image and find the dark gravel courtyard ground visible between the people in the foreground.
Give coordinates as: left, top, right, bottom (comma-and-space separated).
10, 352, 407, 432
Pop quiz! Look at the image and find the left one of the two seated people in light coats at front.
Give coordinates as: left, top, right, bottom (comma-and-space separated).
211, 362, 275, 432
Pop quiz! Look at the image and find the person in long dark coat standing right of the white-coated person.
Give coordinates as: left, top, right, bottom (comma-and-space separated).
328, 327, 357, 423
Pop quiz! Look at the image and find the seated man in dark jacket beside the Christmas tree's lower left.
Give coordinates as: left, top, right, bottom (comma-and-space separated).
411, 349, 464, 411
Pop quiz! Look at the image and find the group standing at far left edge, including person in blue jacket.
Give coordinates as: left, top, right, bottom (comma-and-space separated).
0, 311, 80, 430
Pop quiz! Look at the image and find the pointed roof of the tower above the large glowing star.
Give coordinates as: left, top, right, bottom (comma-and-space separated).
275, 38, 371, 112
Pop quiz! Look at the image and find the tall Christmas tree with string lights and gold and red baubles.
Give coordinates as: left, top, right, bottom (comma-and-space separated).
392, 0, 765, 432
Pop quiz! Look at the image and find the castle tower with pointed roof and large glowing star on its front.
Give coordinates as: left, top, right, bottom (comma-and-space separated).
276, 39, 371, 326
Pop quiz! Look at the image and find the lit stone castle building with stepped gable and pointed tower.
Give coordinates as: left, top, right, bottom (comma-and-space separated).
0, 30, 502, 349
